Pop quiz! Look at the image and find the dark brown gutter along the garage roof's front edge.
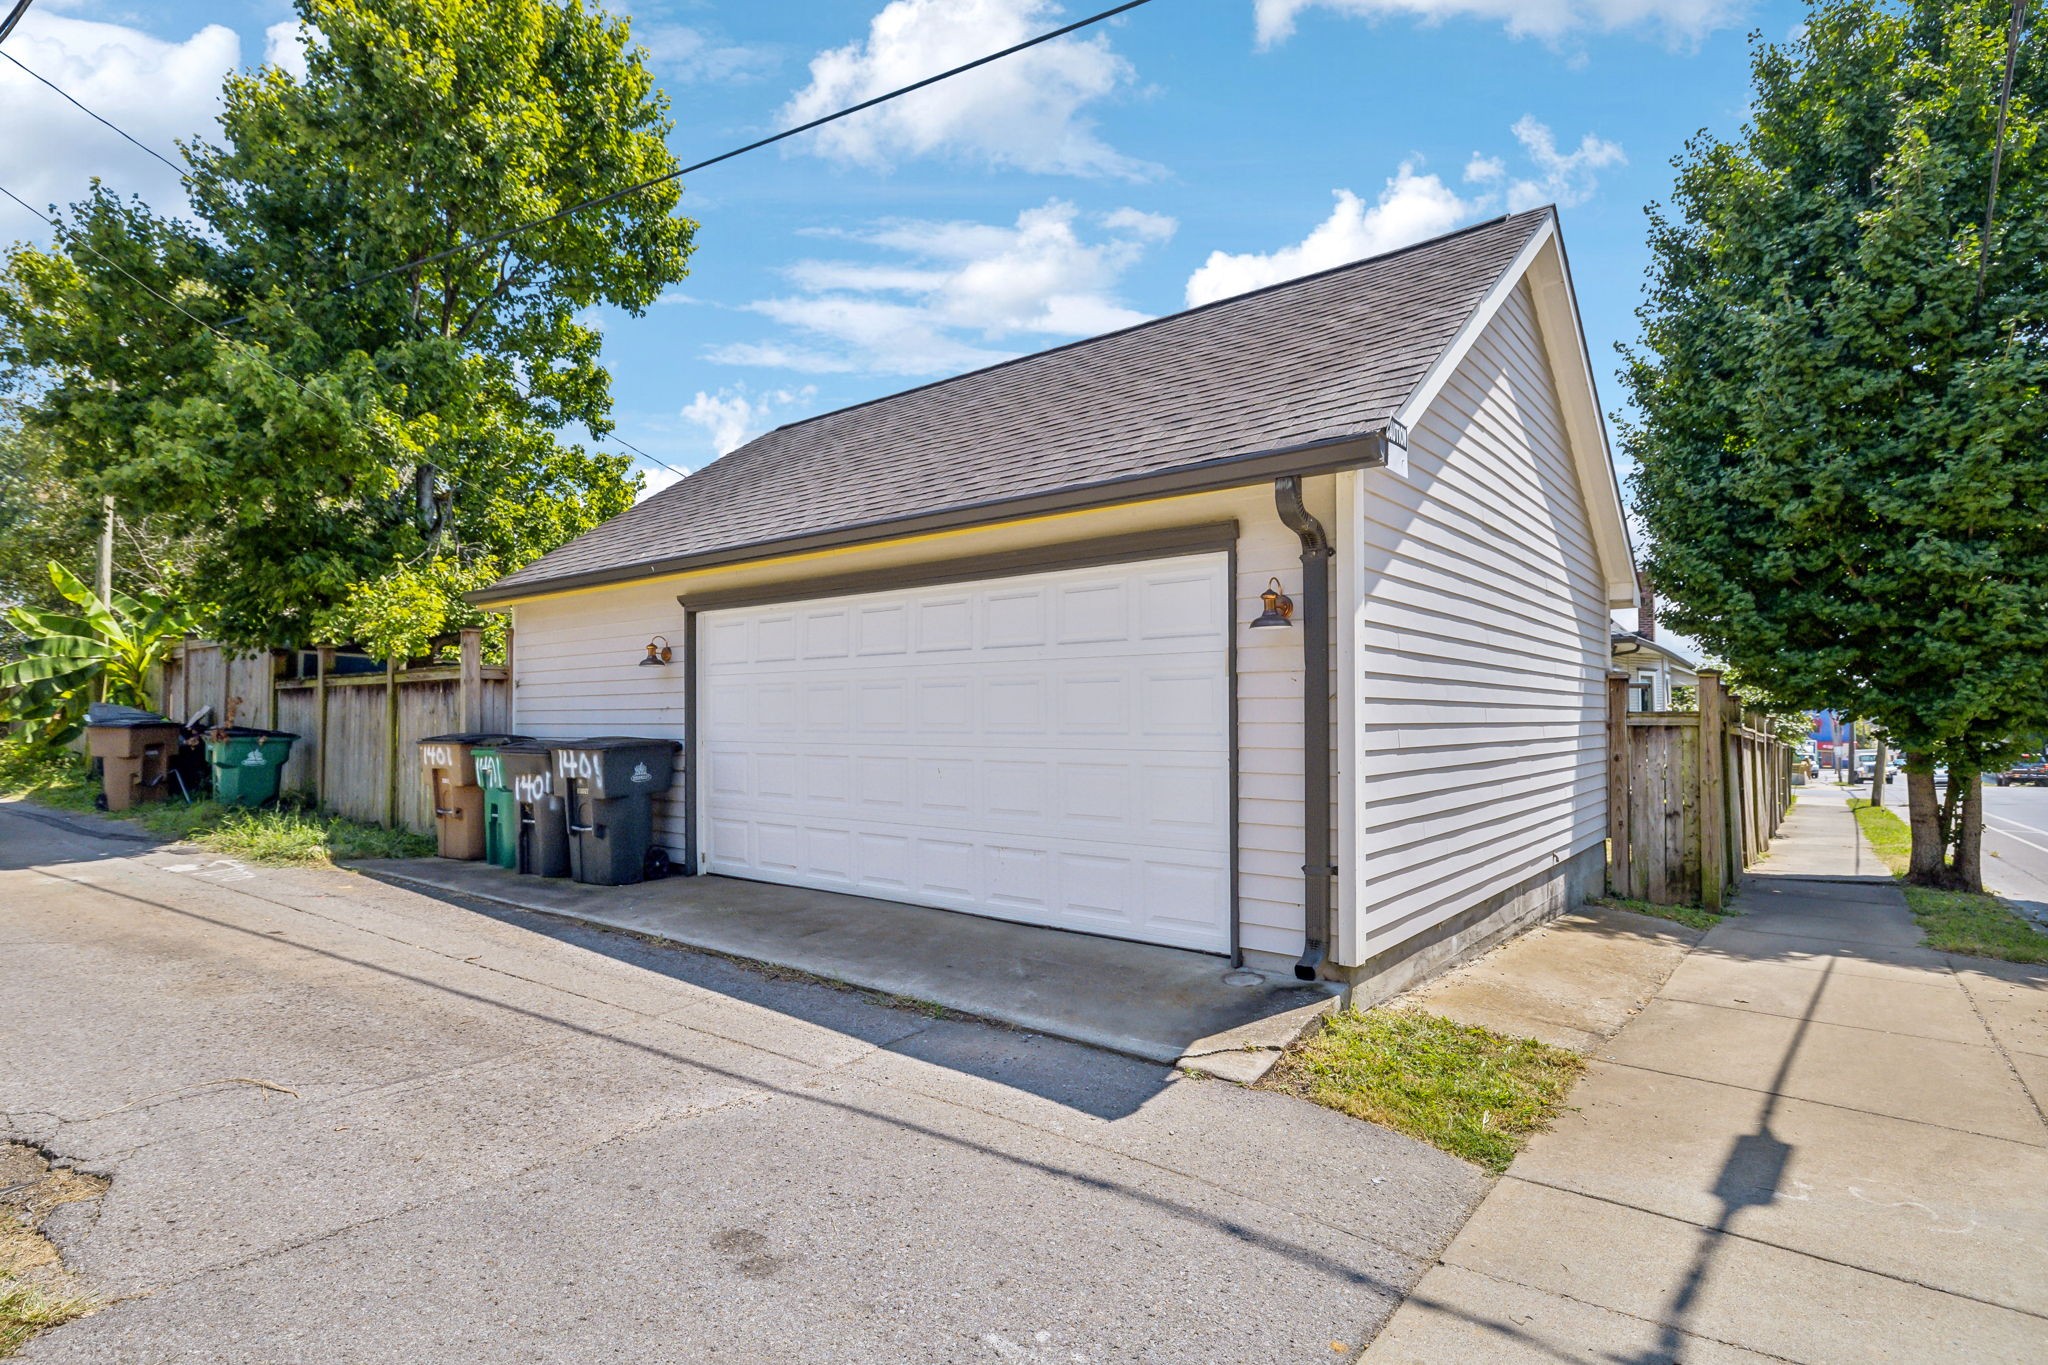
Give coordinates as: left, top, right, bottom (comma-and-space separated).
463, 424, 1386, 608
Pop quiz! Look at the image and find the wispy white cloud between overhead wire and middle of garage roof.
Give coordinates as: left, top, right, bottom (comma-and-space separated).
713, 201, 1178, 375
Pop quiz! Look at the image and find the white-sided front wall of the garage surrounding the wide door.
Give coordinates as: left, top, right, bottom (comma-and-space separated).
495, 477, 1335, 966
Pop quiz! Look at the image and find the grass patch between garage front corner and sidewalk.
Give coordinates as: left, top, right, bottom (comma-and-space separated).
1262, 1009, 1585, 1175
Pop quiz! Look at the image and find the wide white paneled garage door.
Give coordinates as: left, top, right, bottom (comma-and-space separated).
698, 555, 1231, 952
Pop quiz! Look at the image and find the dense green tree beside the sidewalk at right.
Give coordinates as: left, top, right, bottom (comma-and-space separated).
1624, 0, 2048, 888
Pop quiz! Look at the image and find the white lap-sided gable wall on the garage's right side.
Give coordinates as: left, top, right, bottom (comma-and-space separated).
1343, 284, 1608, 970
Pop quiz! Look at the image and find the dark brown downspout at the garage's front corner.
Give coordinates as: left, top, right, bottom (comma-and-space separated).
1274, 475, 1337, 980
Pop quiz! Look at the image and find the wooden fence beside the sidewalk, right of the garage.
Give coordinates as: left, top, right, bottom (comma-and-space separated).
1608, 669, 1792, 911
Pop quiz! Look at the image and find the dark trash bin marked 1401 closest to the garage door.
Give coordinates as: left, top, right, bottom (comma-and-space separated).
547, 735, 682, 886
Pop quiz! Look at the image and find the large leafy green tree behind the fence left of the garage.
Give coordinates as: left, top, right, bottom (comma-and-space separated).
0, 0, 694, 647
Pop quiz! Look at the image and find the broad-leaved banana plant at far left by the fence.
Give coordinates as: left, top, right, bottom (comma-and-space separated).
0, 563, 193, 747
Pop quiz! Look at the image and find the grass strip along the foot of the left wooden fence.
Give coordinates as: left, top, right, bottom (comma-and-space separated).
0, 745, 434, 868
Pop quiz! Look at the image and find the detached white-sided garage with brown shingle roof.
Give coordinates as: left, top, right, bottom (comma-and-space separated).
473, 209, 1634, 995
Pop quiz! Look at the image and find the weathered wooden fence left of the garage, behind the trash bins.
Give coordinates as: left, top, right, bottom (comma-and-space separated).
162, 630, 512, 833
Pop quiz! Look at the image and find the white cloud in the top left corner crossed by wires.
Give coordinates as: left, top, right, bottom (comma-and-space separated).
0, 8, 242, 224
